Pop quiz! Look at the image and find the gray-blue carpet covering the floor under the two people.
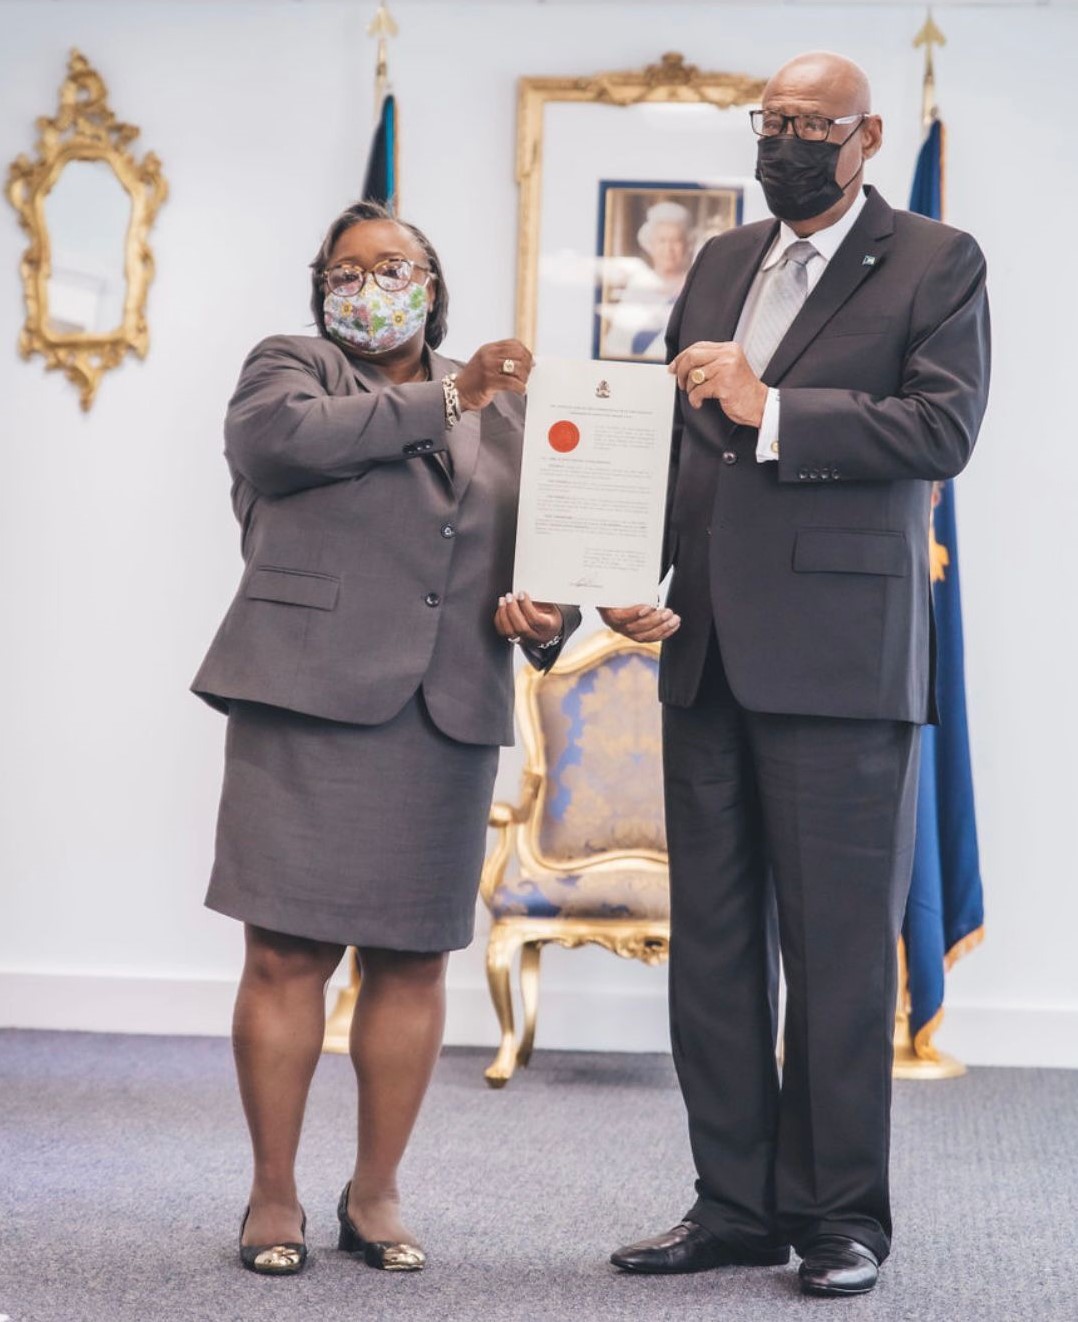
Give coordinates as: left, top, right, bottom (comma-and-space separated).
0, 1031, 1078, 1322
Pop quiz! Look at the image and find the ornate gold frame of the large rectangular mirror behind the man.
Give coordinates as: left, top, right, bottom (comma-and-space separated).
516, 52, 766, 348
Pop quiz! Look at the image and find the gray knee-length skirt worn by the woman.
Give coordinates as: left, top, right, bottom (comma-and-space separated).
206, 694, 499, 952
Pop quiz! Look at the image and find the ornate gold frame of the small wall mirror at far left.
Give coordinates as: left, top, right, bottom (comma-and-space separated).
7, 50, 168, 410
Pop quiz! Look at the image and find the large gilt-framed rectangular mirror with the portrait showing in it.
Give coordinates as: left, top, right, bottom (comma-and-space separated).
516, 54, 770, 362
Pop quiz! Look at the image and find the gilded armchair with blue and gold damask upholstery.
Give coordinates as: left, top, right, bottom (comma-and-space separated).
480, 631, 669, 1088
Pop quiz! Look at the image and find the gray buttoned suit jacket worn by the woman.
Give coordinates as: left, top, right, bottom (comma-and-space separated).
192, 336, 579, 744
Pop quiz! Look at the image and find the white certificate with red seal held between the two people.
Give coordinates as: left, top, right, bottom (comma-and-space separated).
513, 358, 677, 605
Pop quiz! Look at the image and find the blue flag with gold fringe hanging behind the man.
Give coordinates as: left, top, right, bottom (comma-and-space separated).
902, 119, 984, 1060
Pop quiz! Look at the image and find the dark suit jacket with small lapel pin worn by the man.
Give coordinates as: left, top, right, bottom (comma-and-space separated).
660, 188, 989, 722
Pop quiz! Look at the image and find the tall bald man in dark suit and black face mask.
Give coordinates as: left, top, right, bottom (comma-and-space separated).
603, 53, 988, 1294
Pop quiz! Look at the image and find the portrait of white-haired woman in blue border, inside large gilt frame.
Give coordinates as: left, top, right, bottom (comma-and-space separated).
591, 180, 745, 362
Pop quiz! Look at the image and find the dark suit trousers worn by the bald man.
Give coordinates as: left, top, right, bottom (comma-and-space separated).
663, 640, 919, 1261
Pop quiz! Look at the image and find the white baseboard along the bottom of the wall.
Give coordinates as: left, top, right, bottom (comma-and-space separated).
0, 970, 1078, 1069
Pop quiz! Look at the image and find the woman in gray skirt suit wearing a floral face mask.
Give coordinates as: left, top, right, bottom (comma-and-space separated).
193, 204, 579, 1274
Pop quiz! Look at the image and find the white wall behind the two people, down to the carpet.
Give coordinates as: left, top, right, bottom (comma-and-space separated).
0, 0, 1078, 1066
